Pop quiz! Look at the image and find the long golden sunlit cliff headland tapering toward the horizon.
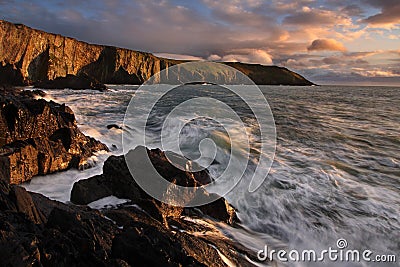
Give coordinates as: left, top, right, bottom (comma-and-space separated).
0, 20, 312, 85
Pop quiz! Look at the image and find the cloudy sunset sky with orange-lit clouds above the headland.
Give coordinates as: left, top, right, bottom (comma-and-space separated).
0, 0, 400, 85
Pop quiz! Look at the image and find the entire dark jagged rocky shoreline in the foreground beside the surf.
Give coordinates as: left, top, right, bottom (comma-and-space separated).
0, 89, 268, 266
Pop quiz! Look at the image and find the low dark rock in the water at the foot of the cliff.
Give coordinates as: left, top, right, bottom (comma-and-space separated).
34, 74, 107, 91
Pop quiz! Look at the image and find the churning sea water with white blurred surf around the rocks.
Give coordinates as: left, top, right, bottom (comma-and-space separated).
24, 85, 400, 266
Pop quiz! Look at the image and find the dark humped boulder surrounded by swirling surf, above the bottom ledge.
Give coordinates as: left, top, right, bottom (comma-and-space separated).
71, 147, 237, 224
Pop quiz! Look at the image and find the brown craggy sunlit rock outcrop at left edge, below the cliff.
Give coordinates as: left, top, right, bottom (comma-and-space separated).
0, 89, 108, 184
